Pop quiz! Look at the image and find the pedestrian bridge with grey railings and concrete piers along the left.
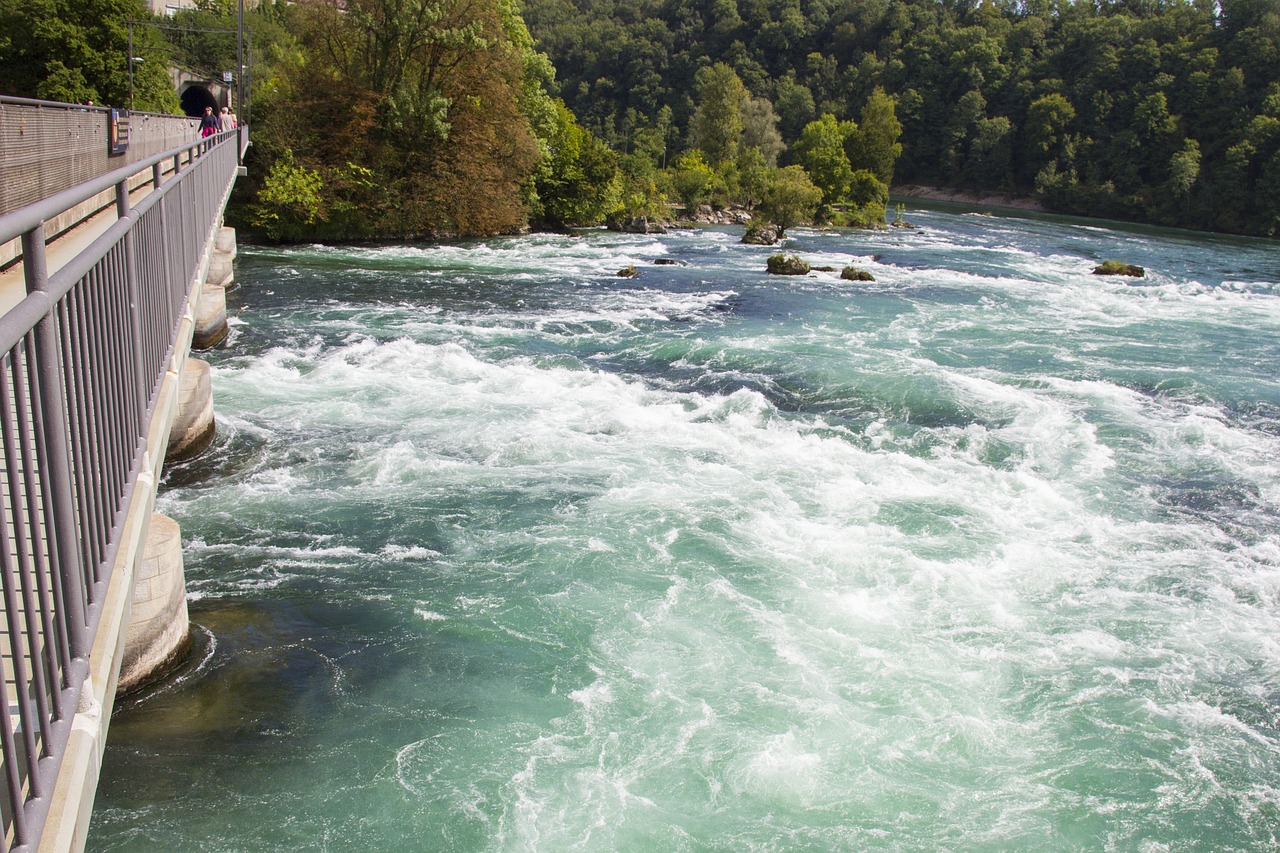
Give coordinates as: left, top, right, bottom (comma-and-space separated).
0, 99, 248, 850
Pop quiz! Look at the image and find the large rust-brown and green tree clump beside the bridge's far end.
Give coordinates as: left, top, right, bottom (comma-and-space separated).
235, 0, 545, 240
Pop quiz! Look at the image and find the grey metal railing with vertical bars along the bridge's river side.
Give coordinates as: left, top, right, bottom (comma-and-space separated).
0, 122, 247, 850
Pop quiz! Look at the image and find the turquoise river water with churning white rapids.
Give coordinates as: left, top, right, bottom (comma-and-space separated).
90, 210, 1280, 853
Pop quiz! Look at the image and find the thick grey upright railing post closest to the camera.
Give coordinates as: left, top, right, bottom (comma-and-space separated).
22, 224, 90, 653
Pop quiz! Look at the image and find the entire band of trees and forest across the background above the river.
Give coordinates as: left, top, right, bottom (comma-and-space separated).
0, 0, 1280, 240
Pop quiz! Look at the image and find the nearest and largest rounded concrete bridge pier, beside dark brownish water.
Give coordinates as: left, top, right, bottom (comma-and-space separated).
115, 514, 191, 695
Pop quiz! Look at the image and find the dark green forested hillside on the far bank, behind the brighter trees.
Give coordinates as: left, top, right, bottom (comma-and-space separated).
525, 0, 1280, 236
